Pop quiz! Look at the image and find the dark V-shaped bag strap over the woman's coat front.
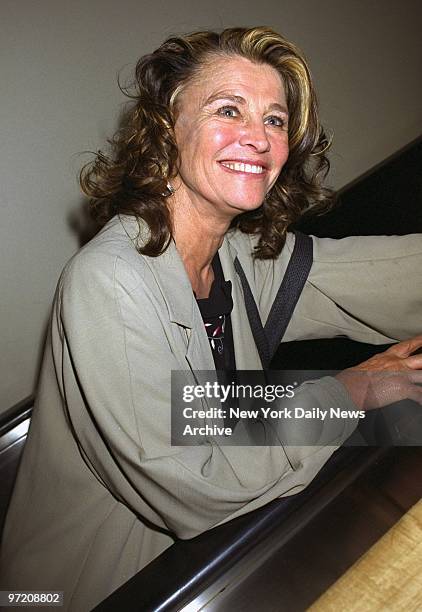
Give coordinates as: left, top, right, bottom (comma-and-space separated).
234, 231, 313, 369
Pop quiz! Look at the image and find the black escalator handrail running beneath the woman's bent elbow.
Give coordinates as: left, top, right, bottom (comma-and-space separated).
95, 447, 390, 612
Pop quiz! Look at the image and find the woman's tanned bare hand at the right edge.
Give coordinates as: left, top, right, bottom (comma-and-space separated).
336, 335, 422, 410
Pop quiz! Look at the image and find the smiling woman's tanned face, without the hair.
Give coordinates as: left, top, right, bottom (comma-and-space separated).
175, 56, 289, 221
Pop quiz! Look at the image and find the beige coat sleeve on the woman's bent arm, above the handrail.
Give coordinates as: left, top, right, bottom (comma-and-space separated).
56, 246, 355, 538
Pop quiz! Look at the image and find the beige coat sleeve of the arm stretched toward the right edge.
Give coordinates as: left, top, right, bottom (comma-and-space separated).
255, 234, 422, 344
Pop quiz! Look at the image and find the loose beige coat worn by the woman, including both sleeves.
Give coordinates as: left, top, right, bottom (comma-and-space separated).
0, 217, 422, 612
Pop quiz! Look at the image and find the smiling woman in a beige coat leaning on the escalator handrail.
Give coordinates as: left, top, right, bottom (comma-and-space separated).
3, 28, 422, 611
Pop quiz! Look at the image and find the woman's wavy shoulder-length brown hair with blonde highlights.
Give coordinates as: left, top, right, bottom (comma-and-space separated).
80, 27, 332, 259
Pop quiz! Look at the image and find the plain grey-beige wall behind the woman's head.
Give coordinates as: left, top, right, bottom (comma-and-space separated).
0, 0, 422, 411
